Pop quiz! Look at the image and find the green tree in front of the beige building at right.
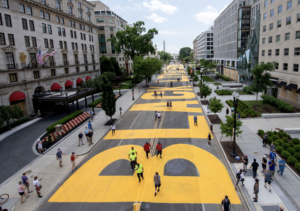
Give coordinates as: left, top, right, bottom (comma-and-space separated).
251, 62, 274, 102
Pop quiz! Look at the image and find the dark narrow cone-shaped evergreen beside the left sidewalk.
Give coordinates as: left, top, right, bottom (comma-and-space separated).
101, 75, 116, 119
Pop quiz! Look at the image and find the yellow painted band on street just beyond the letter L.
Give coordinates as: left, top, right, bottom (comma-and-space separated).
130, 100, 202, 113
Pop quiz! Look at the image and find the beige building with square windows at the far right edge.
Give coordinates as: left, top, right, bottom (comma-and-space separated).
259, 0, 300, 108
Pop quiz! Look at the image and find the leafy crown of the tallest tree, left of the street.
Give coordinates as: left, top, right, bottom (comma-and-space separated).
107, 21, 158, 61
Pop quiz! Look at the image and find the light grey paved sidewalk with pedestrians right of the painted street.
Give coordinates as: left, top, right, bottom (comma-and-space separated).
194, 81, 300, 211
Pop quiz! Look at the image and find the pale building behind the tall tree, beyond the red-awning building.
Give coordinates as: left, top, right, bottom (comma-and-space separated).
90, 1, 133, 70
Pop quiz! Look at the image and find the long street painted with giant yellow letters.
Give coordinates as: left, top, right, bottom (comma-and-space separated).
38, 65, 246, 211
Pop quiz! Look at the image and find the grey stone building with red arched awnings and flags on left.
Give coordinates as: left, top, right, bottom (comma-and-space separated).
0, 0, 100, 114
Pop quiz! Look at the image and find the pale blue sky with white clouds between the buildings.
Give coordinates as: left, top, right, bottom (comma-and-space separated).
89, 0, 232, 53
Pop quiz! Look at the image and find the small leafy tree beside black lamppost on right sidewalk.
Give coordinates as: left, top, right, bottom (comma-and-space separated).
220, 114, 243, 140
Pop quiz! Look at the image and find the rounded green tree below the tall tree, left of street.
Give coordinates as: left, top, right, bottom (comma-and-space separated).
133, 56, 163, 86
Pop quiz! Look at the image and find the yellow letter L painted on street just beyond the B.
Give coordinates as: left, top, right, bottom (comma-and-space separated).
104, 116, 213, 140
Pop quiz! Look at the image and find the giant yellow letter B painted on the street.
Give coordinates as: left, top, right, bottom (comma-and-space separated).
49, 144, 241, 204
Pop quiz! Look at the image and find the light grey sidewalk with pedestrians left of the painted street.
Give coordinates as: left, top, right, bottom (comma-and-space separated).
0, 76, 155, 211
